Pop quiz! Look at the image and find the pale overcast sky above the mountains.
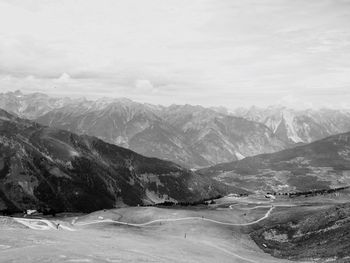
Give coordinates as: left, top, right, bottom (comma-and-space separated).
0, 0, 350, 108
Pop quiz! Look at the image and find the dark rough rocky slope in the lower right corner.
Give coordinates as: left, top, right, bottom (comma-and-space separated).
250, 203, 350, 262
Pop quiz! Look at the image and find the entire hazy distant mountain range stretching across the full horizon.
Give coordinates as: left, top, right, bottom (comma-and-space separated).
0, 91, 350, 168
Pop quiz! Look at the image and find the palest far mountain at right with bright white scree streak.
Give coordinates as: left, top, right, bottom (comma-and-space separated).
234, 106, 350, 143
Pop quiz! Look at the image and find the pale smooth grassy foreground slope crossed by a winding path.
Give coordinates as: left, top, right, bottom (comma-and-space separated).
0, 207, 288, 263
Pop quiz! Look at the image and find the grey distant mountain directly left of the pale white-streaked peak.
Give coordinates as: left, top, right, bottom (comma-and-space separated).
162, 105, 286, 163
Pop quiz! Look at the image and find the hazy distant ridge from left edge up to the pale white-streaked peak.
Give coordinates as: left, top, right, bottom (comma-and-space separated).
0, 91, 289, 167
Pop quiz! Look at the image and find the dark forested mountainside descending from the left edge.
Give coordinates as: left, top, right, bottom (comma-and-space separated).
0, 110, 226, 212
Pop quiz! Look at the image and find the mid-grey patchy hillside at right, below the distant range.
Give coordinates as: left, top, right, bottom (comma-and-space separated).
199, 133, 350, 193
